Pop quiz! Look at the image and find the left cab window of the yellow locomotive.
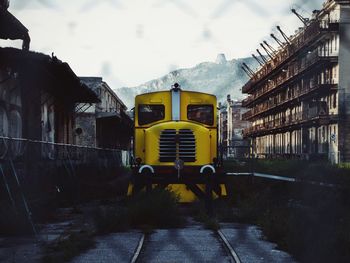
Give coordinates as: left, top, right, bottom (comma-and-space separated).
138, 104, 165, 125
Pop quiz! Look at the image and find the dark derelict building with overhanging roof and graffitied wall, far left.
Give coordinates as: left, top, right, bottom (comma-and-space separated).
0, 1, 98, 147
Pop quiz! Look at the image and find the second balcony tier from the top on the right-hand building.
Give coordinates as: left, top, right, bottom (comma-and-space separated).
242, 53, 338, 107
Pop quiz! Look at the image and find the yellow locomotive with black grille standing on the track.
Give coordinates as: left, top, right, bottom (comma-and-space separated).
128, 83, 226, 202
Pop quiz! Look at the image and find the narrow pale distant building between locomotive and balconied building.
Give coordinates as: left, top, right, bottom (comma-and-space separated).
219, 95, 250, 160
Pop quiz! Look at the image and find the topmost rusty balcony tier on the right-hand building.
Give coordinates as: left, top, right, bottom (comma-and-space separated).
242, 20, 339, 93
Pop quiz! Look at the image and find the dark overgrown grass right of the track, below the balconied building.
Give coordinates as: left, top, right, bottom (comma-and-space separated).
224, 160, 350, 262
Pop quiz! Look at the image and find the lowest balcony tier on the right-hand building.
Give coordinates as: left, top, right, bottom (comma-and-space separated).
243, 101, 336, 137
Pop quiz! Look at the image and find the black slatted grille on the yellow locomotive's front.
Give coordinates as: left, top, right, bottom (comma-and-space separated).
159, 129, 196, 162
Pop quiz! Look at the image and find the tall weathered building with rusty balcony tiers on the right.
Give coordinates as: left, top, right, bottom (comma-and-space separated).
242, 0, 350, 163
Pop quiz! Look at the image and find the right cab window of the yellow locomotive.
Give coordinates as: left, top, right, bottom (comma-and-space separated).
187, 105, 214, 125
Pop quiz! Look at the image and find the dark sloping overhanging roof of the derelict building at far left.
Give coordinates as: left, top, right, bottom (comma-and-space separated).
0, 48, 99, 103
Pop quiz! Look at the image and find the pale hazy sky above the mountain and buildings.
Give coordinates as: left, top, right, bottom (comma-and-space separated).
0, 0, 323, 89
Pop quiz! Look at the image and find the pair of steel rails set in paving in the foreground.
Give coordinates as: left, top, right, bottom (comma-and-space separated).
130, 226, 241, 263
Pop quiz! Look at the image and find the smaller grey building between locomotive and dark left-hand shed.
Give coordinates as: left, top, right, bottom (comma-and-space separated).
75, 77, 133, 150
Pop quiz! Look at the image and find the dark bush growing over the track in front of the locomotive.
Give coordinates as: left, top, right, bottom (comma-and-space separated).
94, 188, 185, 234
